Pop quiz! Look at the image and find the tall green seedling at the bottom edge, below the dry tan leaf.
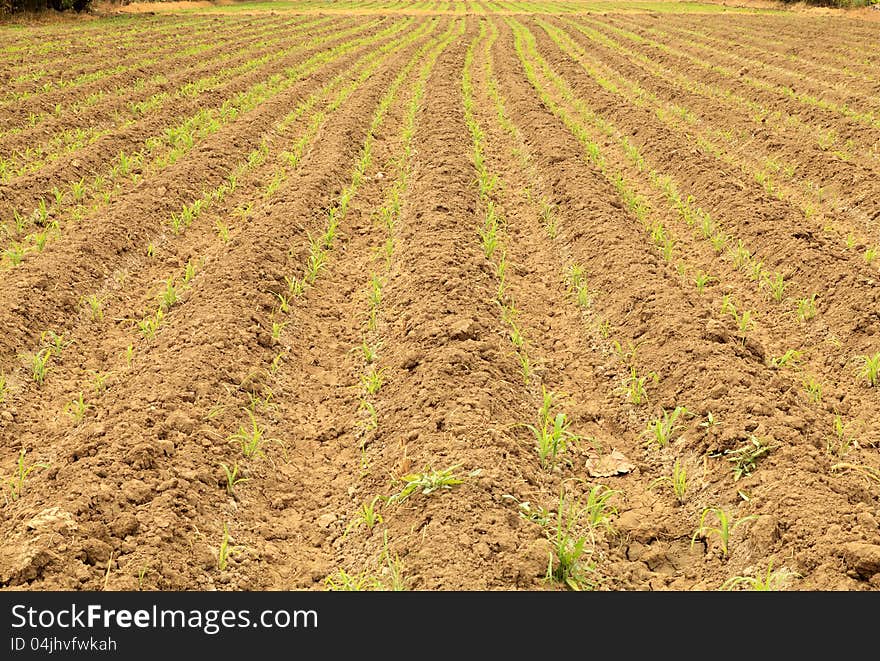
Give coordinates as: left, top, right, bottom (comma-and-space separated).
546, 490, 595, 592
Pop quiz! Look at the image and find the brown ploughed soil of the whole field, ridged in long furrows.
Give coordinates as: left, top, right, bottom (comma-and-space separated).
0, 3, 880, 591
